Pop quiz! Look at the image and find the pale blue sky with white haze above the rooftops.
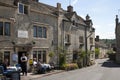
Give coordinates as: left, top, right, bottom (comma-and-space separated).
39, 0, 120, 39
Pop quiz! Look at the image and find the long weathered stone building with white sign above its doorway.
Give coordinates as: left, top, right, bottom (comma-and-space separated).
0, 0, 95, 69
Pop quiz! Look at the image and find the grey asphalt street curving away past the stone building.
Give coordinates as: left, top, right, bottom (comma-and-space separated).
31, 59, 120, 80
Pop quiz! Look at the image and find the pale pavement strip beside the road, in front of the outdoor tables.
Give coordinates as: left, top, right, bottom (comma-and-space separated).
20, 70, 64, 80
